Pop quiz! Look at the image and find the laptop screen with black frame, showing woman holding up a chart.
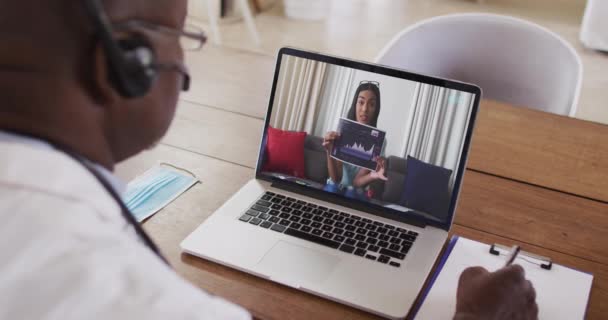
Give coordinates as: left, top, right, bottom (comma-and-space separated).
257, 49, 479, 228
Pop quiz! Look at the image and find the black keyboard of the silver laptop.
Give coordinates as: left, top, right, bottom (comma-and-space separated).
239, 192, 418, 267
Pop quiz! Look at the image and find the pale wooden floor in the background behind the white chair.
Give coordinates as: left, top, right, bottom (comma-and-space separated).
185, 0, 608, 124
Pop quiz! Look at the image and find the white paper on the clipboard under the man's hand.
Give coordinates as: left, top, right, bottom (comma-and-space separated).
415, 236, 593, 320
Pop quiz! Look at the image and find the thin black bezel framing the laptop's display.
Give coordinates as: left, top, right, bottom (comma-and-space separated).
255, 47, 481, 231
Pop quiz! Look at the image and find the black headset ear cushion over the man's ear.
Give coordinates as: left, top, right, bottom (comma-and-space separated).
117, 35, 156, 97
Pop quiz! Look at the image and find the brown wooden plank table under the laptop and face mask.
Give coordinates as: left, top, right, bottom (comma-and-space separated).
117, 46, 608, 319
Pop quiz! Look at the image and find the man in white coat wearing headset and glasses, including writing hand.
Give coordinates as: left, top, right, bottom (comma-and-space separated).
0, 0, 537, 319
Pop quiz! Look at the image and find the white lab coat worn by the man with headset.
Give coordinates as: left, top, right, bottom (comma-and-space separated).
0, 140, 250, 320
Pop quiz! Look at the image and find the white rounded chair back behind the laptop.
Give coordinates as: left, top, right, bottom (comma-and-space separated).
376, 13, 583, 117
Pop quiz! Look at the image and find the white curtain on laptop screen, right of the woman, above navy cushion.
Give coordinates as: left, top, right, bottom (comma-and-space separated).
403, 83, 473, 172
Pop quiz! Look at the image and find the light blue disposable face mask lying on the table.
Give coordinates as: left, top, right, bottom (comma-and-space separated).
123, 166, 198, 222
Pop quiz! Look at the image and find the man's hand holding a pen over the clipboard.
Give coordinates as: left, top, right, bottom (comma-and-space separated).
454, 265, 538, 320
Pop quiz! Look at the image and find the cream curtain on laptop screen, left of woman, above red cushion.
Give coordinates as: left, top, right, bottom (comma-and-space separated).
270, 55, 327, 132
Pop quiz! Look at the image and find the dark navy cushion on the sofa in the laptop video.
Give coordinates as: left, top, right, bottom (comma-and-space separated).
400, 156, 452, 220
